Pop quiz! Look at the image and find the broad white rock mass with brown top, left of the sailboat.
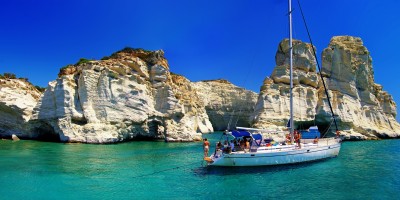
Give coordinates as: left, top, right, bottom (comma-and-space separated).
32, 48, 213, 143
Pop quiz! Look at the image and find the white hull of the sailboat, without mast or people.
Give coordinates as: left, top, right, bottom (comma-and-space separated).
208, 141, 341, 167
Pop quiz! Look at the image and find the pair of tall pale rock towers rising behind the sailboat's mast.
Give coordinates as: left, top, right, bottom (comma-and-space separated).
252, 36, 400, 139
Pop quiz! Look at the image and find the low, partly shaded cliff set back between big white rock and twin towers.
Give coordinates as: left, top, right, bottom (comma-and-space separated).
192, 80, 258, 130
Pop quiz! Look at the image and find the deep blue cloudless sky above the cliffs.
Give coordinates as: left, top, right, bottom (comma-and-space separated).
0, 0, 400, 119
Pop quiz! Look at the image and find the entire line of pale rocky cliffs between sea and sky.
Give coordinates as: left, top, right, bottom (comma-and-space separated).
0, 36, 400, 144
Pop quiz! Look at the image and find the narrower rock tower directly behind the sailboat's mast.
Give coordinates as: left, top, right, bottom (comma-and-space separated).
252, 39, 319, 128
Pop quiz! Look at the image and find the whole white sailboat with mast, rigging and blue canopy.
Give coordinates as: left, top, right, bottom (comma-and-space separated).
204, 0, 341, 167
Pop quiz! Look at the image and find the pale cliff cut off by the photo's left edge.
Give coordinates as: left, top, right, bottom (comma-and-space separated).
0, 78, 42, 138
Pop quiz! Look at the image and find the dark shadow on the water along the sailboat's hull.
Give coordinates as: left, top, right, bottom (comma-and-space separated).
193, 158, 331, 176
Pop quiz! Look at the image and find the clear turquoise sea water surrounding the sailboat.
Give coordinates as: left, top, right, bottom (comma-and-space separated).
0, 133, 400, 199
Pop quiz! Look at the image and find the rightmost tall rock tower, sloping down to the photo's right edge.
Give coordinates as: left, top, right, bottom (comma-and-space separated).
317, 36, 400, 138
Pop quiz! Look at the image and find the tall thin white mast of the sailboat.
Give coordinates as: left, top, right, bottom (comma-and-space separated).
289, 0, 294, 143
